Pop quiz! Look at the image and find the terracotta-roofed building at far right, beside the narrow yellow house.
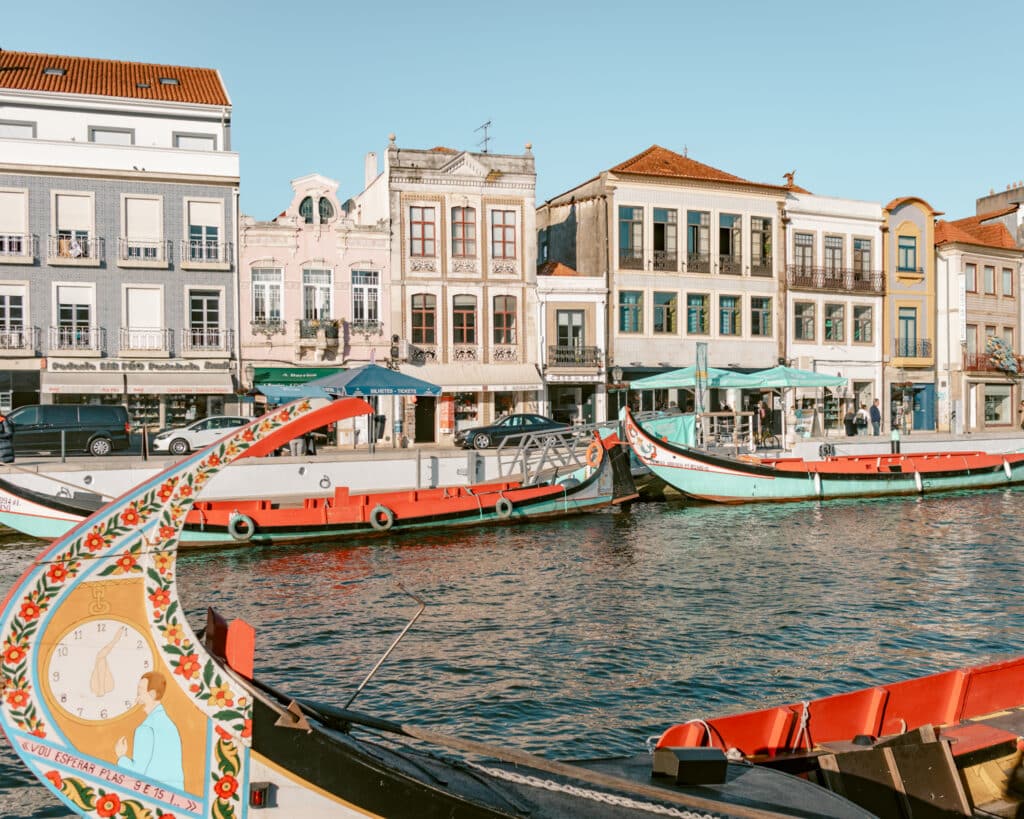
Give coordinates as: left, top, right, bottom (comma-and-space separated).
935, 210, 1024, 432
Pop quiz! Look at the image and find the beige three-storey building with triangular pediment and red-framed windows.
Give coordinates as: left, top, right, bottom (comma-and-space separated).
350, 136, 543, 442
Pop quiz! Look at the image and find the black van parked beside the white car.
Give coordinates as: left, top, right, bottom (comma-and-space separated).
7, 403, 130, 455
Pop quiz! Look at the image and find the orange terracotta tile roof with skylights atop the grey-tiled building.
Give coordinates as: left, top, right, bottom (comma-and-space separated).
0, 51, 231, 105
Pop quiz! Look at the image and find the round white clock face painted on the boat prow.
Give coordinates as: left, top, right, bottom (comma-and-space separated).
46, 617, 153, 721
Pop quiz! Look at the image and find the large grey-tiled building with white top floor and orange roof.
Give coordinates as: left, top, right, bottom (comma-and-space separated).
0, 51, 239, 426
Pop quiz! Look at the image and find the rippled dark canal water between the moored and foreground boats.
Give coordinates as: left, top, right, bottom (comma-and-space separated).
0, 489, 1024, 817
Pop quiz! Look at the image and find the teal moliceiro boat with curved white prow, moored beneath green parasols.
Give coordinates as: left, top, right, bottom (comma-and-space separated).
624, 411, 1024, 504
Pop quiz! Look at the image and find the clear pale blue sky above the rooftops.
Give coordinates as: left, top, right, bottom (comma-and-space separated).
9, 0, 1024, 219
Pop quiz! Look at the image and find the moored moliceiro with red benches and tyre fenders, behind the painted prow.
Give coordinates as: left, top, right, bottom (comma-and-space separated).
0, 398, 636, 548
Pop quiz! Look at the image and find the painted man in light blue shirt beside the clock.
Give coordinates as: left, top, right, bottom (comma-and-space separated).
114, 672, 185, 790
